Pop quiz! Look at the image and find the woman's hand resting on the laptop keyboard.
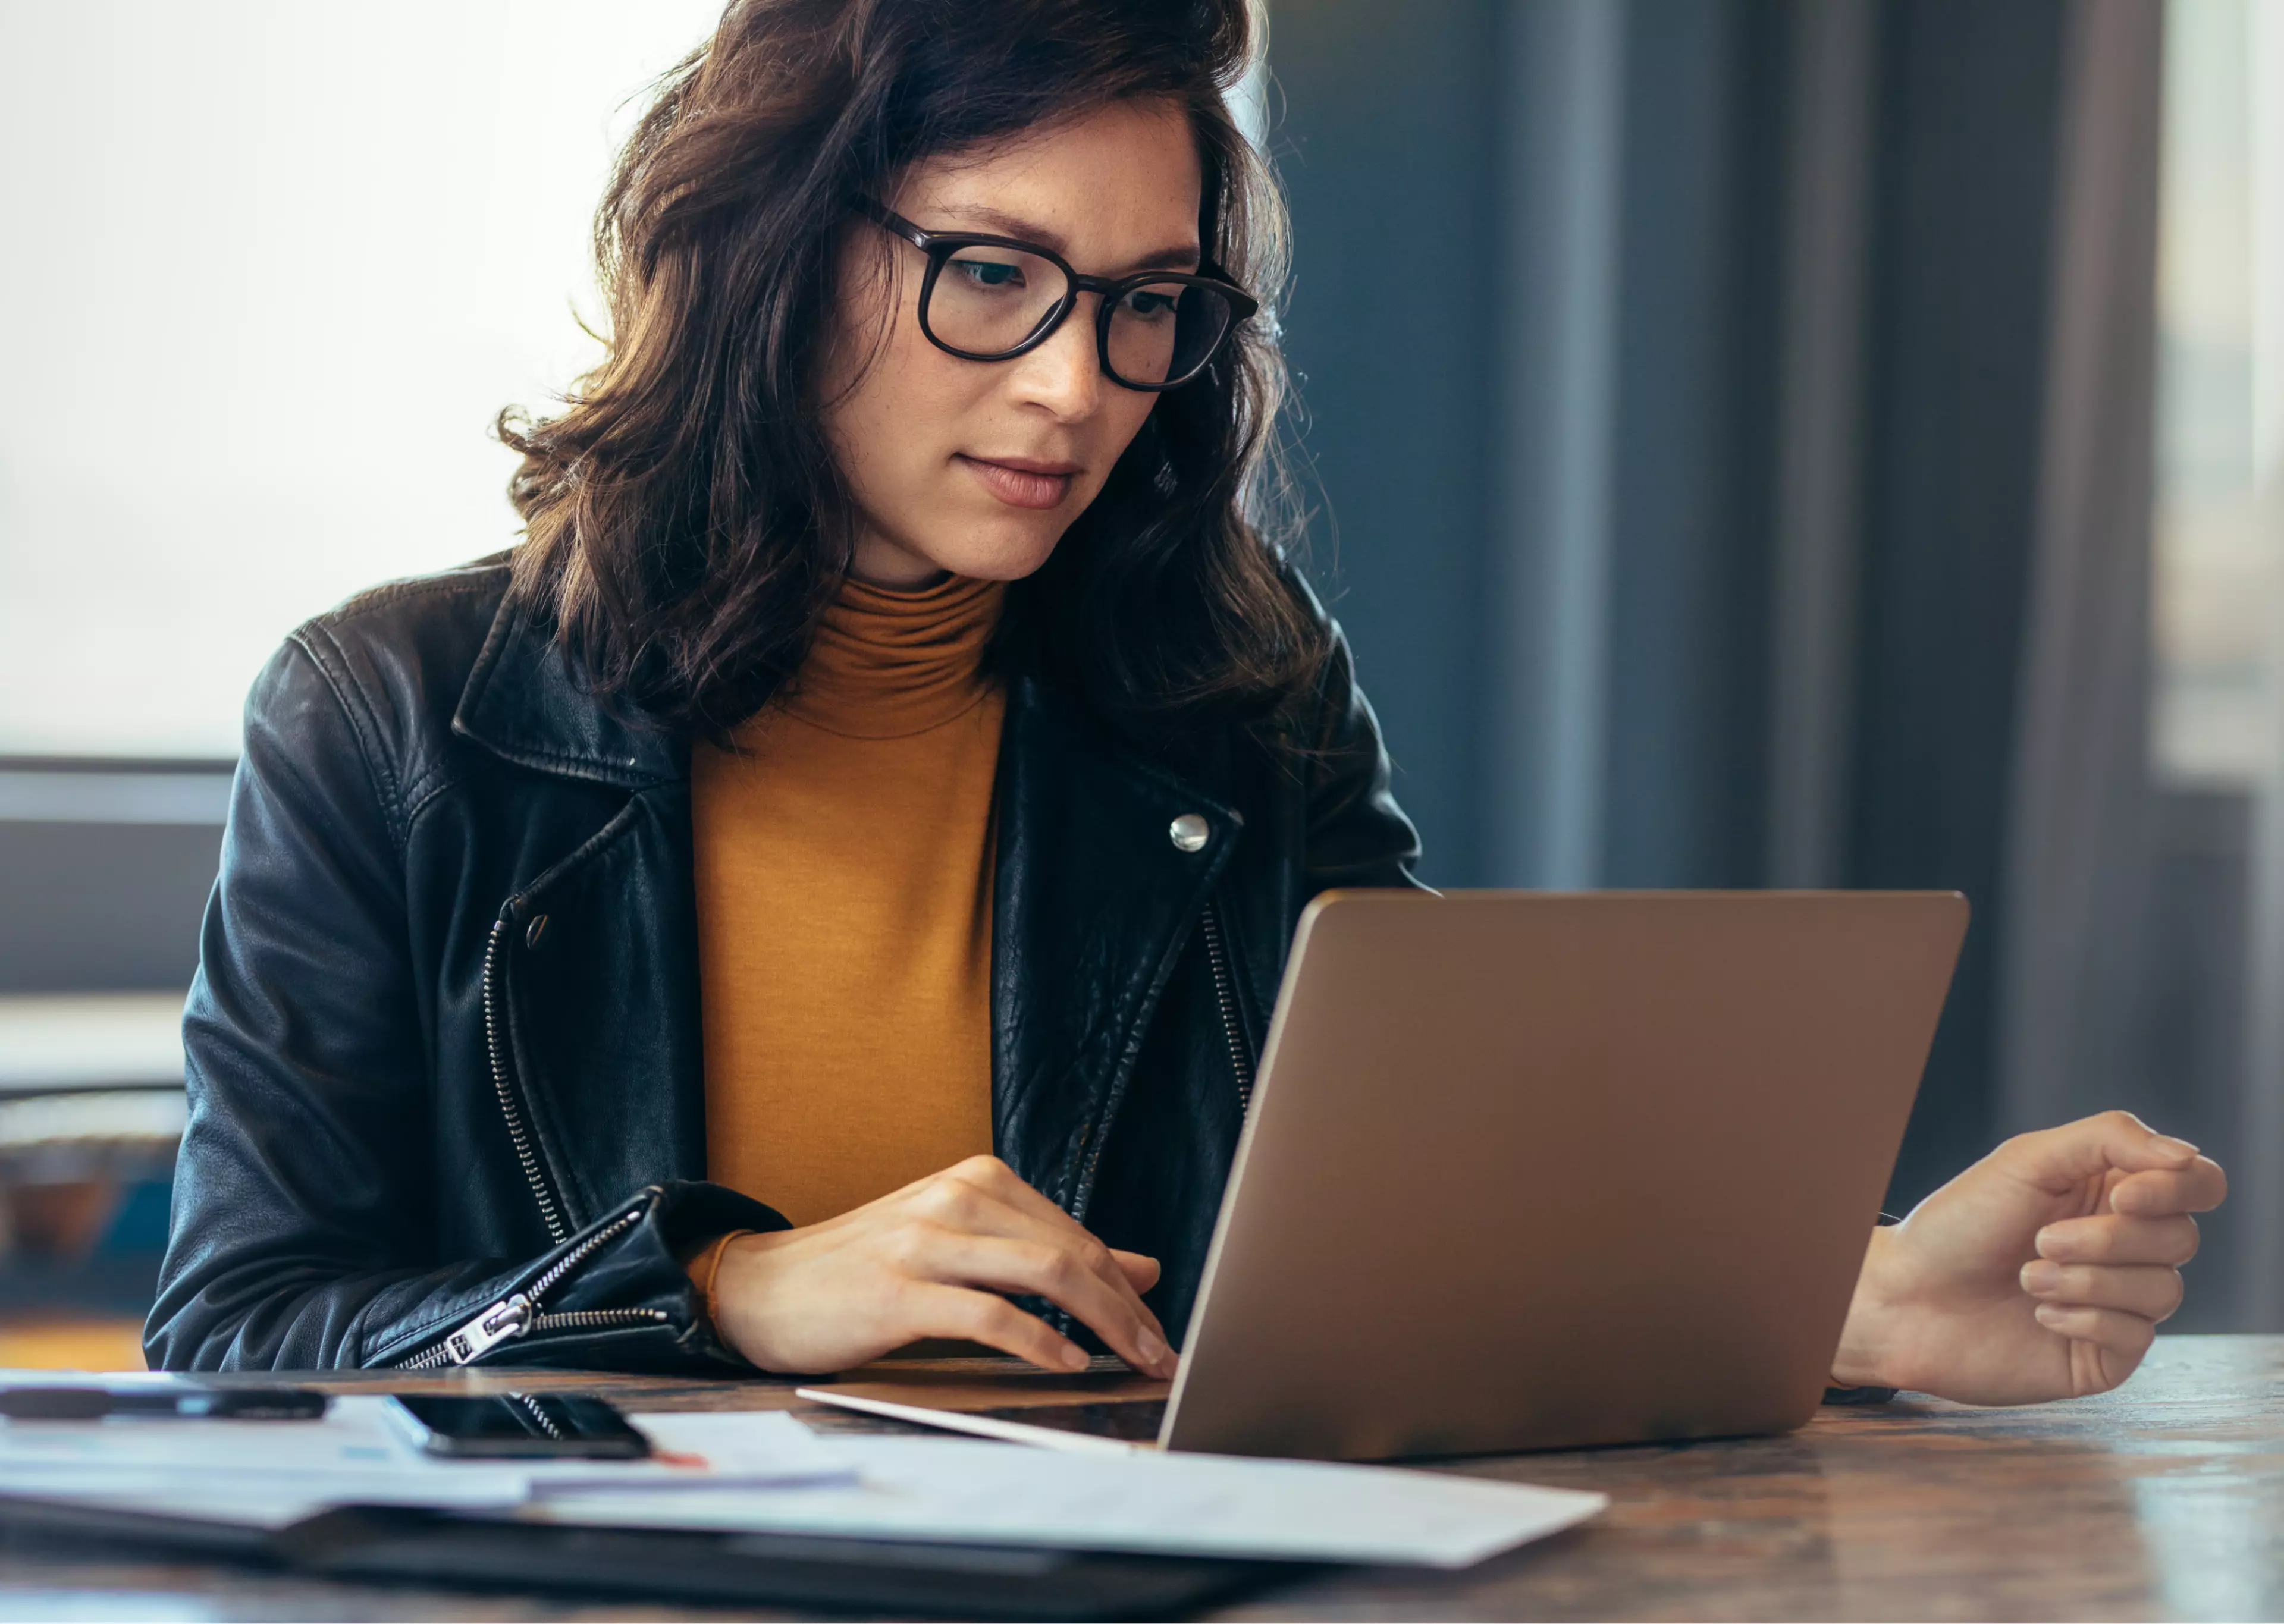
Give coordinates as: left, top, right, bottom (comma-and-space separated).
713, 1156, 1174, 1377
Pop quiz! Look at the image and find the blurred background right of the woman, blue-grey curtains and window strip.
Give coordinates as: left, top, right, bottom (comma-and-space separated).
1270, 0, 2284, 1327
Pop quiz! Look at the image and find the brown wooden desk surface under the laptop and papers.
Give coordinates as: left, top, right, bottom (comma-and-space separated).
0, 1336, 2284, 1624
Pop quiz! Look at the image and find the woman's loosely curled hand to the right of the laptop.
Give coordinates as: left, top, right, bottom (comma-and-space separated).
1832, 1110, 2229, 1405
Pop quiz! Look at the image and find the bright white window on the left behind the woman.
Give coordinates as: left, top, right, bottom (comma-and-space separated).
0, 0, 720, 758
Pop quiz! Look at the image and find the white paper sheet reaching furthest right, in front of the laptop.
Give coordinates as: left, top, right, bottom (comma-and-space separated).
523, 1437, 1608, 1567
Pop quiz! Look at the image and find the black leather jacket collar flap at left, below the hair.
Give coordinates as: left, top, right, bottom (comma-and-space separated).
452, 601, 690, 790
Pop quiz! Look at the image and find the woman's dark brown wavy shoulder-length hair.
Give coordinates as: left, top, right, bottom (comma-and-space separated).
498, 0, 1327, 740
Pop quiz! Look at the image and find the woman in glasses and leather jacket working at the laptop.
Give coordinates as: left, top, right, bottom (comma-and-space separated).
146, 0, 2220, 1400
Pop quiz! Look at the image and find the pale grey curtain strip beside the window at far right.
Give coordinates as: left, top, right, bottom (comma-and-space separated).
2001, 0, 2165, 1130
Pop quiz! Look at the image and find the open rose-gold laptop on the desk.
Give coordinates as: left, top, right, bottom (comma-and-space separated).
804, 891, 1966, 1459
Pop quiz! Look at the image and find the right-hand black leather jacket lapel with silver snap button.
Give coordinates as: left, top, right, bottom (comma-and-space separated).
992, 679, 1243, 1215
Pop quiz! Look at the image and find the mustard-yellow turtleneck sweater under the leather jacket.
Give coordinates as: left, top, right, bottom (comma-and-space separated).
690, 576, 1005, 1224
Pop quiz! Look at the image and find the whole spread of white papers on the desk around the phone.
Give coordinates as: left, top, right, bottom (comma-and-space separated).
0, 1396, 1606, 1567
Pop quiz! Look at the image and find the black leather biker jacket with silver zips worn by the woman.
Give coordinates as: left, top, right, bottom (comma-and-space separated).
144, 560, 1416, 1371
